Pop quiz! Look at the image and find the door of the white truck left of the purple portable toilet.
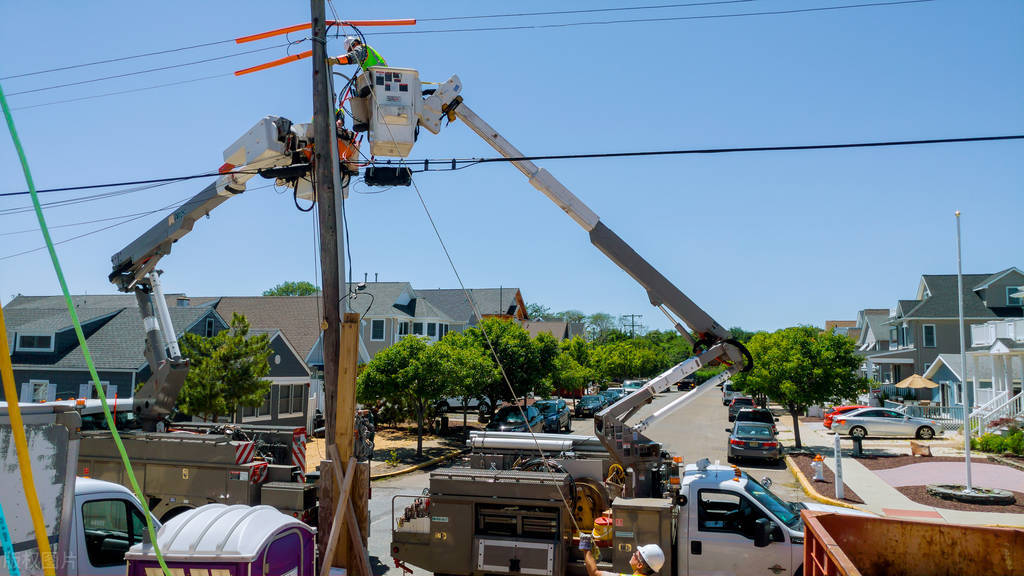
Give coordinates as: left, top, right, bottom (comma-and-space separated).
74, 494, 152, 576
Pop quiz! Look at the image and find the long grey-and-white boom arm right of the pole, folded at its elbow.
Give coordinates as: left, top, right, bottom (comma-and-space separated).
420, 76, 753, 494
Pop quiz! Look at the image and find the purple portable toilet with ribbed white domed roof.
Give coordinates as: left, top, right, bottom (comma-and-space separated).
125, 504, 315, 576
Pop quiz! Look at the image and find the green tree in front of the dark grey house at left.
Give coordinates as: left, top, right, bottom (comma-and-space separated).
178, 314, 273, 421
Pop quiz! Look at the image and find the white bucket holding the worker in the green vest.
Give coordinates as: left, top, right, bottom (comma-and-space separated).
369, 66, 423, 158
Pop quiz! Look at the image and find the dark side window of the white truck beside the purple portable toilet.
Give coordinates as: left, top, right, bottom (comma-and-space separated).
82, 499, 145, 567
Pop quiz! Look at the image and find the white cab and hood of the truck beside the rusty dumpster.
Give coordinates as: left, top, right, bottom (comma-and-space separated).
675, 460, 870, 576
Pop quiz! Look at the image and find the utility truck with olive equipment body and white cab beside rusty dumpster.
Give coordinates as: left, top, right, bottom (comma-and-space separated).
391, 448, 869, 576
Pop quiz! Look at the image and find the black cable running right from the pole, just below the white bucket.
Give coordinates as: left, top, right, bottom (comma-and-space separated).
403, 134, 1024, 172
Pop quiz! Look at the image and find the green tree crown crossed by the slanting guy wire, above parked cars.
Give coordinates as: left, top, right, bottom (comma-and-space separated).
465, 318, 558, 410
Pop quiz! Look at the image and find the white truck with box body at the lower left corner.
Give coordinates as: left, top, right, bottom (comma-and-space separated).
0, 403, 160, 576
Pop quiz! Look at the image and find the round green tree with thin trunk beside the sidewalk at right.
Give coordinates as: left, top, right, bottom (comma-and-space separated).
735, 326, 868, 448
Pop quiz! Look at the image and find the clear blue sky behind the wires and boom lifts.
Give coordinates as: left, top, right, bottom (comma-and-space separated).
0, 0, 1024, 329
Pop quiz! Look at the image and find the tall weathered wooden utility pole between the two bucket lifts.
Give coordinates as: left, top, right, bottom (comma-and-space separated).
309, 0, 344, 562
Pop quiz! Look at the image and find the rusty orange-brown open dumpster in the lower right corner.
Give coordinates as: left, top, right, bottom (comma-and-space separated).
801, 510, 1024, 576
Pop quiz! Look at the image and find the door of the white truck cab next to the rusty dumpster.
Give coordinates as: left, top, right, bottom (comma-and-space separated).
680, 489, 793, 576
